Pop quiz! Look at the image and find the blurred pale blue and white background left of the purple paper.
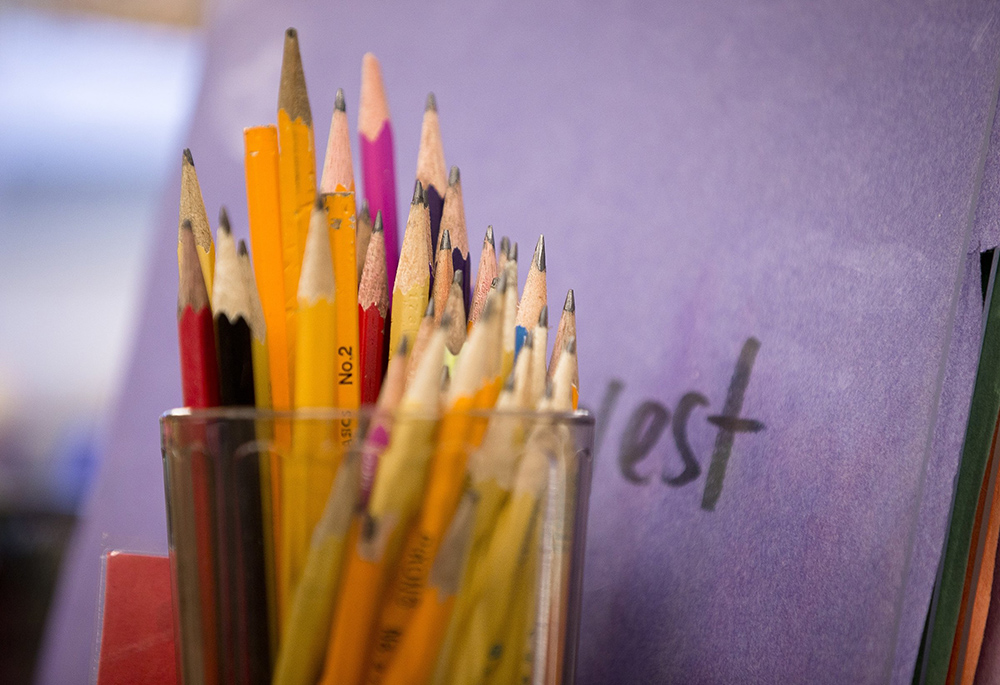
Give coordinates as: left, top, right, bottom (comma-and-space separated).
0, 0, 204, 683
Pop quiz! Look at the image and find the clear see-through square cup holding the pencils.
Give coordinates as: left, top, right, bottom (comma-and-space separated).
160, 408, 594, 685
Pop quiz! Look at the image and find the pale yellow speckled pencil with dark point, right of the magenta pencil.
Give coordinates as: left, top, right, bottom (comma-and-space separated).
389, 181, 431, 358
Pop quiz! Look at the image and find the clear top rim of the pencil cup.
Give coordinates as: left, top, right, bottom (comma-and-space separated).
160, 405, 594, 426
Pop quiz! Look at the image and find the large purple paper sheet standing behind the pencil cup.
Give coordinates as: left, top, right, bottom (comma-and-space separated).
41, 0, 1000, 684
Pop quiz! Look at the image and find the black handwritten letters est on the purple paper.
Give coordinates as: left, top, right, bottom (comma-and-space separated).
594, 338, 764, 511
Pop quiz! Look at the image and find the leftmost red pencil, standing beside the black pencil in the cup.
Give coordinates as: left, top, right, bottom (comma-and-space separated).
176, 219, 219, 683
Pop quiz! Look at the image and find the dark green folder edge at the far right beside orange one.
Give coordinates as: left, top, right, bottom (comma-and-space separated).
913, 249, 1000, 685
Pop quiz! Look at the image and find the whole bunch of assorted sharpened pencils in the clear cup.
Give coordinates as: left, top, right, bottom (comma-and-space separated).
170, 29, 579, 684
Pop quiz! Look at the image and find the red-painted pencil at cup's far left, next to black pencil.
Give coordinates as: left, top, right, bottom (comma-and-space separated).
178, 220, 219, 683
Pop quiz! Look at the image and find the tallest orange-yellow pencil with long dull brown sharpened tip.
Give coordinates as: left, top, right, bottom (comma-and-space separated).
278, 29, 316, 390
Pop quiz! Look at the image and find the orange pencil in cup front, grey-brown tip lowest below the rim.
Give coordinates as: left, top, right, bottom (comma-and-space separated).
382, 490, 476, 685
